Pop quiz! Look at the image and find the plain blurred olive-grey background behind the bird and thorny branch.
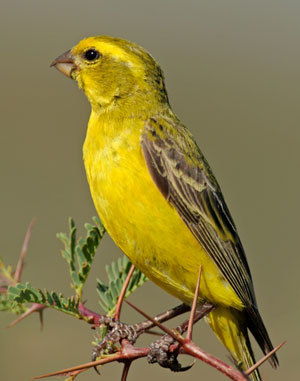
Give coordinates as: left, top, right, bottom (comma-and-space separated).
0, 0, 300, 381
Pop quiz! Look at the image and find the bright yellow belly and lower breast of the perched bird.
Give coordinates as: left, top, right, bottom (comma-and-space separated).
85, 137, 243, 309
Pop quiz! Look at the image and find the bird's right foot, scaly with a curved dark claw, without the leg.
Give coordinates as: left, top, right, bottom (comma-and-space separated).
147, 335, 193, 372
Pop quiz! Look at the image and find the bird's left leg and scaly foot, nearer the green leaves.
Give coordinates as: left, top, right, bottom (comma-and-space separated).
92, 304, 190, 361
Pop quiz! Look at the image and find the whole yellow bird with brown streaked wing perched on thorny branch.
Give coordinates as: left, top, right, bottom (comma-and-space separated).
52, 36, 278, 380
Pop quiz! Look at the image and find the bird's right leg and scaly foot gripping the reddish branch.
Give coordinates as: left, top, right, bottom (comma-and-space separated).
147, 303, 214, 372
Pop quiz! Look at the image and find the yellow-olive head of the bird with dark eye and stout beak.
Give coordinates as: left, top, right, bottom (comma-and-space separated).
51, 36, 168, 114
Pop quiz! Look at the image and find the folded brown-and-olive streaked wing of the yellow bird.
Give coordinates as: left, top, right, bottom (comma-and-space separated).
141, 117, 256, 309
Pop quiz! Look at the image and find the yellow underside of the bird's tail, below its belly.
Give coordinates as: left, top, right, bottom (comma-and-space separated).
206, 307, 261, 381
